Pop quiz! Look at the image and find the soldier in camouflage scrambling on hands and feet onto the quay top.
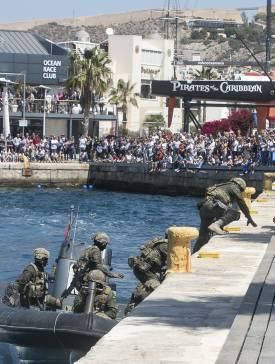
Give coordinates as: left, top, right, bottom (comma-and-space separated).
193, 177, 257, 253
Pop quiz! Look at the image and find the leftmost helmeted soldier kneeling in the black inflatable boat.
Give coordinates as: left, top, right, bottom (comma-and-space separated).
3, 248, 62, 311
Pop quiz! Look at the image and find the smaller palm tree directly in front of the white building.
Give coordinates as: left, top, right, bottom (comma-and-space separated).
109, 78, 138, 127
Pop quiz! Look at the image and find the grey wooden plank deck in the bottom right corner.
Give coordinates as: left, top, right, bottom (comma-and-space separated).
216, 237, 275, 364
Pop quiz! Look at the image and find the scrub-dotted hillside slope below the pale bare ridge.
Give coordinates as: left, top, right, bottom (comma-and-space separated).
31, 17, 270, 61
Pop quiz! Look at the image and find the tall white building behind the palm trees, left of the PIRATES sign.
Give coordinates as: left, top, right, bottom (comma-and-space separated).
108, 35, 182, 134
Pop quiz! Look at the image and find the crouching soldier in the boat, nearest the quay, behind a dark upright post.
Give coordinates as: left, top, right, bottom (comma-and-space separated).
73, 269, 117, 319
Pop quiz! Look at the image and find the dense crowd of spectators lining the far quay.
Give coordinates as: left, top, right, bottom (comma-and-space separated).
0, 130, 275, 174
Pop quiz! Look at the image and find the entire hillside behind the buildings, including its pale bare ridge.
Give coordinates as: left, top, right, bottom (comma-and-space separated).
0, 9, 270, 61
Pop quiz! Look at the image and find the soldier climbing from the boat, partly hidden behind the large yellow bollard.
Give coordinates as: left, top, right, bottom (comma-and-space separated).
125, 231, 168, 314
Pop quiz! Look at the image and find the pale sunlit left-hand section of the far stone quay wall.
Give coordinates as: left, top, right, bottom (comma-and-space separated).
0, 163, 89, 187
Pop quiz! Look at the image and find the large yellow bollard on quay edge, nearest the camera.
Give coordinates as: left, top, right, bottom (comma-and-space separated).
167, 226, 199, 273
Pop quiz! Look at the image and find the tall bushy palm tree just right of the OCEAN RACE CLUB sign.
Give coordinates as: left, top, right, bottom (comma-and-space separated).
66, 47, 111, 135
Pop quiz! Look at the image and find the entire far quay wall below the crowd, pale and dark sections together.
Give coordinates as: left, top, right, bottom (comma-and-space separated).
0, 162, 266, 196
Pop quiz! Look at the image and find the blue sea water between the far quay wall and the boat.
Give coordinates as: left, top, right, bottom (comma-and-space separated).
0, 186, 200, 363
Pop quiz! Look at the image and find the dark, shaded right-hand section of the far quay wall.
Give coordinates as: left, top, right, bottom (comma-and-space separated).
89, 163, 264, 196
